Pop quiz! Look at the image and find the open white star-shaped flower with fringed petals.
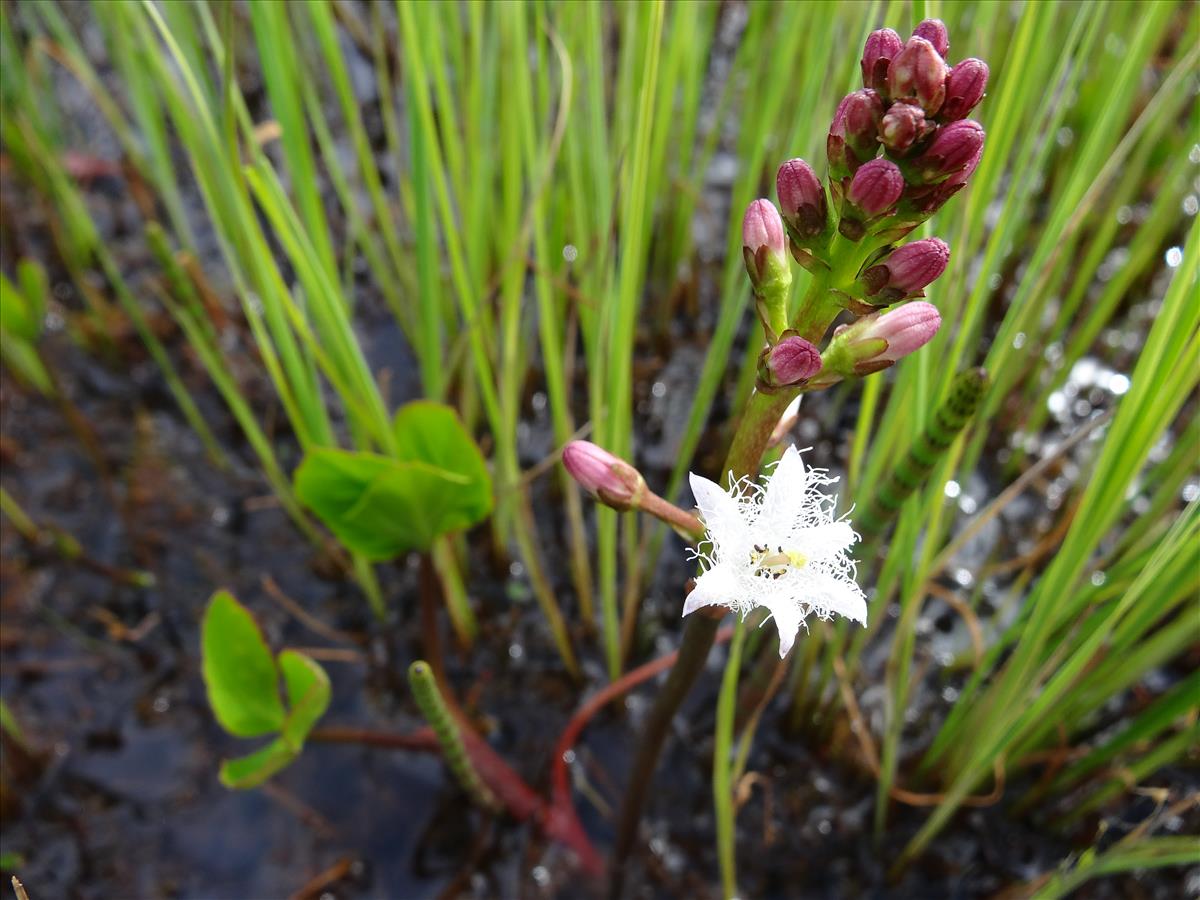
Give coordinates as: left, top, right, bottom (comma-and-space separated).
683, 446, 866, 656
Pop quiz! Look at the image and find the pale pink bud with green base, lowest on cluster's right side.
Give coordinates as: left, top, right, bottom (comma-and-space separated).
809, 301, 942, 386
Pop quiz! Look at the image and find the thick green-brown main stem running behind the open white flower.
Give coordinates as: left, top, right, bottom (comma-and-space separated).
608, 278, 838, 896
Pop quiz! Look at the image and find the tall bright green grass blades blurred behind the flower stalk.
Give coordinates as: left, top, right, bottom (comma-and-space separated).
0, 0, 1200, 890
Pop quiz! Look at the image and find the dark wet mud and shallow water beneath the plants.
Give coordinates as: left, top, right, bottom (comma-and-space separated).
0, 1, 1200, 900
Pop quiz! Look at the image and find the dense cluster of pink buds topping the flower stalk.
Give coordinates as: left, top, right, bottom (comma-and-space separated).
742, 19, 988, 391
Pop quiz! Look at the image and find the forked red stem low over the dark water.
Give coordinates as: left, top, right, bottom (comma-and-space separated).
311, 628, 733, 876
